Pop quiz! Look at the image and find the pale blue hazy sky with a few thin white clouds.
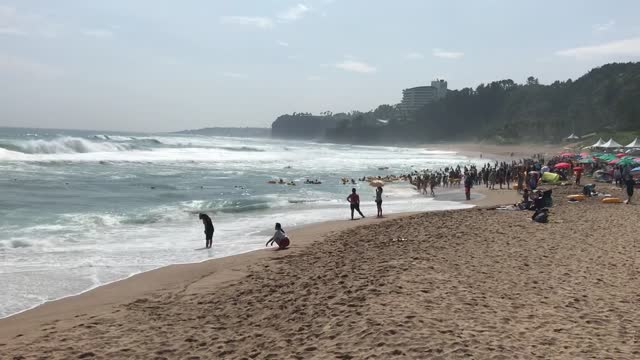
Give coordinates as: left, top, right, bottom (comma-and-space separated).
0, 0, 640, 132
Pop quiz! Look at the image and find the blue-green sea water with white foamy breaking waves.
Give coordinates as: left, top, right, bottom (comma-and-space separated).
0, 128, 480, 317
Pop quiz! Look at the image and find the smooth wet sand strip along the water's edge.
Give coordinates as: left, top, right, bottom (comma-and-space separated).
0, 187, 518, 343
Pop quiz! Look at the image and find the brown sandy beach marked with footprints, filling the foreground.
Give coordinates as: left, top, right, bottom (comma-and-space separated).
0, 184, 640, 359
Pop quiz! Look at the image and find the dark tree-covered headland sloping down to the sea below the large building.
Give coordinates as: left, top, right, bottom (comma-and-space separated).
272, 63, 640, 144
